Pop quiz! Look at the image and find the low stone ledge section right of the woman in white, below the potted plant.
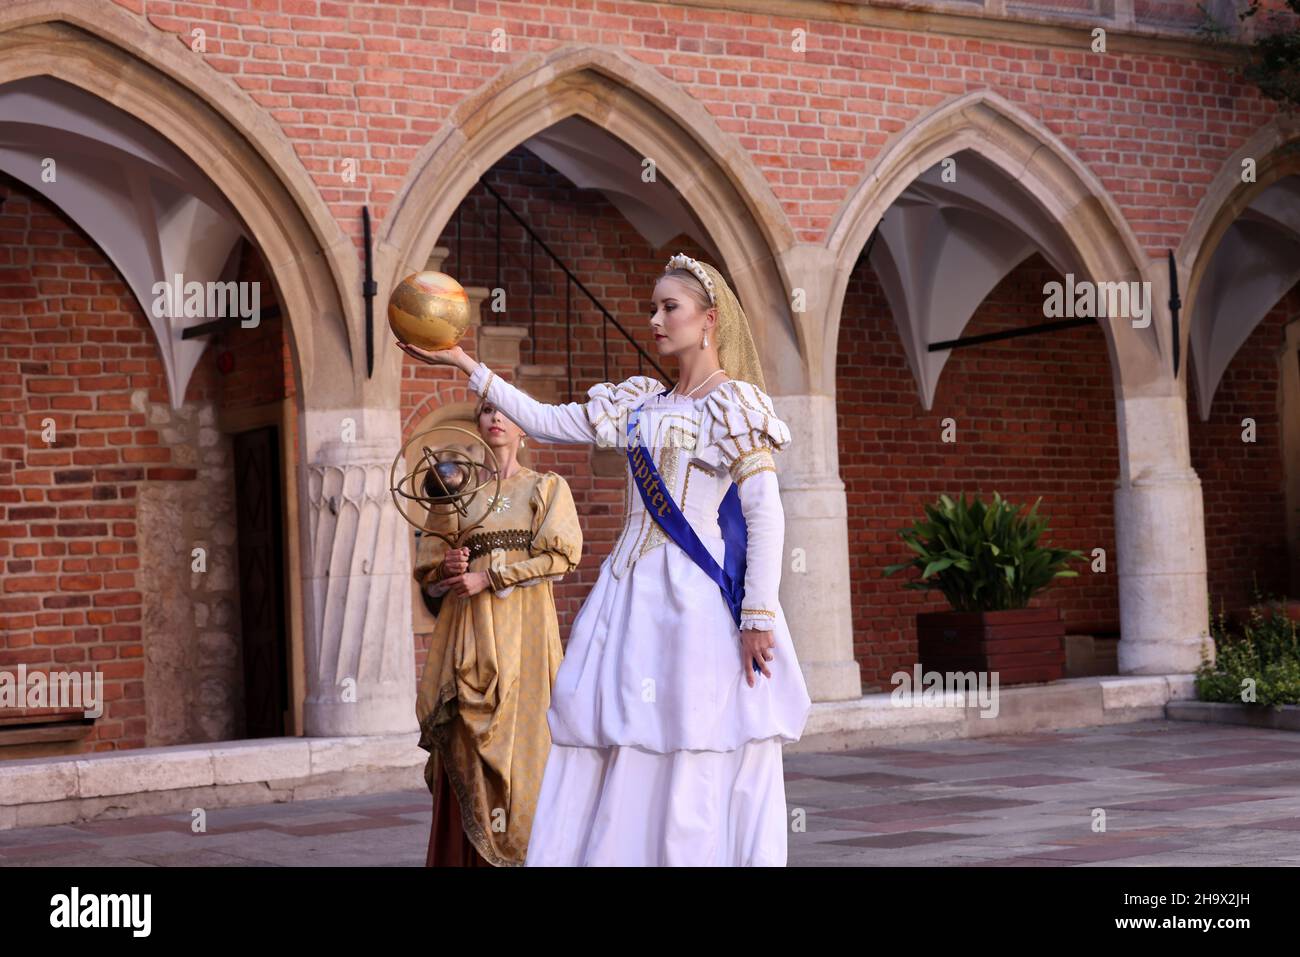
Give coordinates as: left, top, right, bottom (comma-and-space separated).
785, 675, 1195, 754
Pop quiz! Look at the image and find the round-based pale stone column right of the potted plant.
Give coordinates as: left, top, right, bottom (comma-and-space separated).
1114, 395, 1213, 675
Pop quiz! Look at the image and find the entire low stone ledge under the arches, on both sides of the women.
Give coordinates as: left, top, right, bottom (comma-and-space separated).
0, 675, 1206, 830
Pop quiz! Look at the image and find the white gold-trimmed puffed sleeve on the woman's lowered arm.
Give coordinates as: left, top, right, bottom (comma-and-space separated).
699, 380, 790, 631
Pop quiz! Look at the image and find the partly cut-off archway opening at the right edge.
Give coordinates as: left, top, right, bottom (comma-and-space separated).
1179, 117, 1300, 605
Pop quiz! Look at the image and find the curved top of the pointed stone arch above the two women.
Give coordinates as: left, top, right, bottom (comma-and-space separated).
381, 47, 805, 391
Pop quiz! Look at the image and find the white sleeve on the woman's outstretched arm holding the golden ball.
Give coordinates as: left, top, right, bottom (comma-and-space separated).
469, 363, 663, 449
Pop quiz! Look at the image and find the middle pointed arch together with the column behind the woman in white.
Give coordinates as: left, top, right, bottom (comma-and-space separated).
381, 48, 859, 698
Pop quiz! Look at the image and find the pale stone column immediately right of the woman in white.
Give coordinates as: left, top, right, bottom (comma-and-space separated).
772, 395, 862, 701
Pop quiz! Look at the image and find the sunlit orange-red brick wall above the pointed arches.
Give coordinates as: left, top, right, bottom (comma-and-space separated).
116, 0, 1274, 256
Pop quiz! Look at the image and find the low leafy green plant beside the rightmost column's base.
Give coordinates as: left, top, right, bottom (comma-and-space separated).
1196, 579, 1300, 709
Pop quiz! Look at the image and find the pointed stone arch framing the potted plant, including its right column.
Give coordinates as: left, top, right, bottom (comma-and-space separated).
820, 90, 1208, 674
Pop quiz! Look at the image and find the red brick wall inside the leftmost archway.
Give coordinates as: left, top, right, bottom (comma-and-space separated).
0, 181, 243, 750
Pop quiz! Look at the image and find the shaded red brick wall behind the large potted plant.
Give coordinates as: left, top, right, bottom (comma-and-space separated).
836, 255, 1119, 689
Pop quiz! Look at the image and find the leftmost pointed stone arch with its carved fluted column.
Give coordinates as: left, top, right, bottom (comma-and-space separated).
0, 0, 415, 735
